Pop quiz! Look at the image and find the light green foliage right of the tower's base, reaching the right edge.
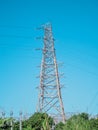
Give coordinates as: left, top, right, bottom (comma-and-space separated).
55, 113, 98, 130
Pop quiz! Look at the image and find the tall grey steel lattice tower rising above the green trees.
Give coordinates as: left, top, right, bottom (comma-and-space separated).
37, 24, 65, 122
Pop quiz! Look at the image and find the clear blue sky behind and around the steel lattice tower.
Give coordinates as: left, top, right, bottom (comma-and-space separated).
0, 0, 98, 115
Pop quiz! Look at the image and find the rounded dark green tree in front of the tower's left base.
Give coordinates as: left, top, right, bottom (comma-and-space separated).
23, 113, 54, 130
